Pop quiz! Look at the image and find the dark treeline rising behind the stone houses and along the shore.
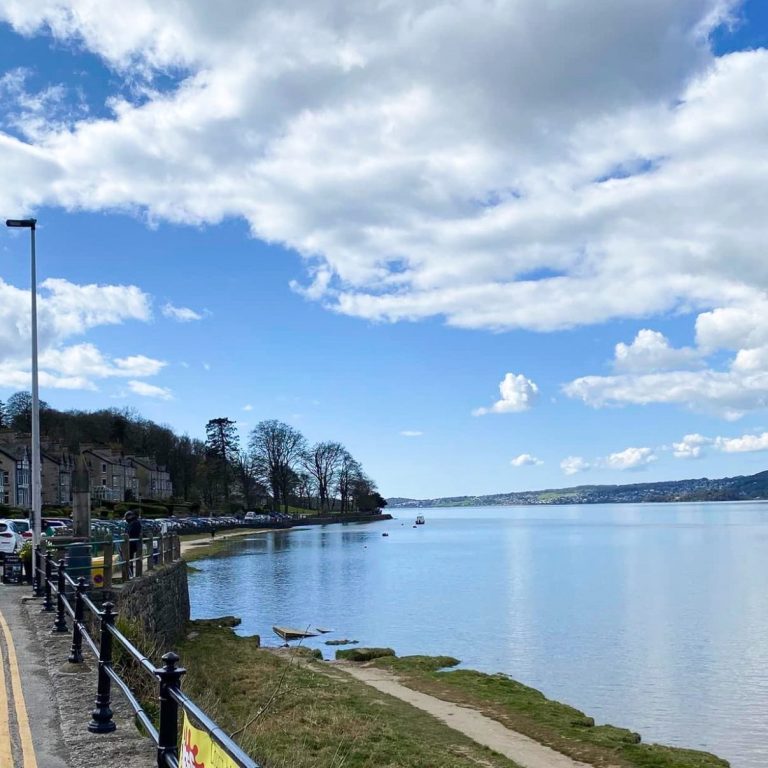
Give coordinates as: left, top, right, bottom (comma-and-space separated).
0, 392, 386, 512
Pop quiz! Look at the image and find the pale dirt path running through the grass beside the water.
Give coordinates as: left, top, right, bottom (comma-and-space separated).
334, 664, 592, 768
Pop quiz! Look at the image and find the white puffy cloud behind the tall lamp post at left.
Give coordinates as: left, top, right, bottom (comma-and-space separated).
0, 278, 158, 390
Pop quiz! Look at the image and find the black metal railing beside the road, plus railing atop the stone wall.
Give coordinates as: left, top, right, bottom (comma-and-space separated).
33, 535, 259, 768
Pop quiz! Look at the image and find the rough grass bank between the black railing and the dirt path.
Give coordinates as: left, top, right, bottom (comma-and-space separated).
178, 623, 518, 768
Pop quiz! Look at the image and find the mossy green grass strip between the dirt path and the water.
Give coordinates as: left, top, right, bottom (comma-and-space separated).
373, 656, 728, 768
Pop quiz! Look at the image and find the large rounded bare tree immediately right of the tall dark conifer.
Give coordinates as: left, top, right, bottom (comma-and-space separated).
248, 419, 307, 512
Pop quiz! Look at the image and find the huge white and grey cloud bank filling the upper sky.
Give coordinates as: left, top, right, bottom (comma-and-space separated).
0, 0, 768, 342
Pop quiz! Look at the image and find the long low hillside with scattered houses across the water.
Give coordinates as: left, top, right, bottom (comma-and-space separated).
387, 471, 768, 508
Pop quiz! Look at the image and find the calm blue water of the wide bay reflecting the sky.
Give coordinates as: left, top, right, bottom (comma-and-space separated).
190, 504, 768, 768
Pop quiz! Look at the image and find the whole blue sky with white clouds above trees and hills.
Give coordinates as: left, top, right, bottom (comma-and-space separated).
0, 0, 768, 497
